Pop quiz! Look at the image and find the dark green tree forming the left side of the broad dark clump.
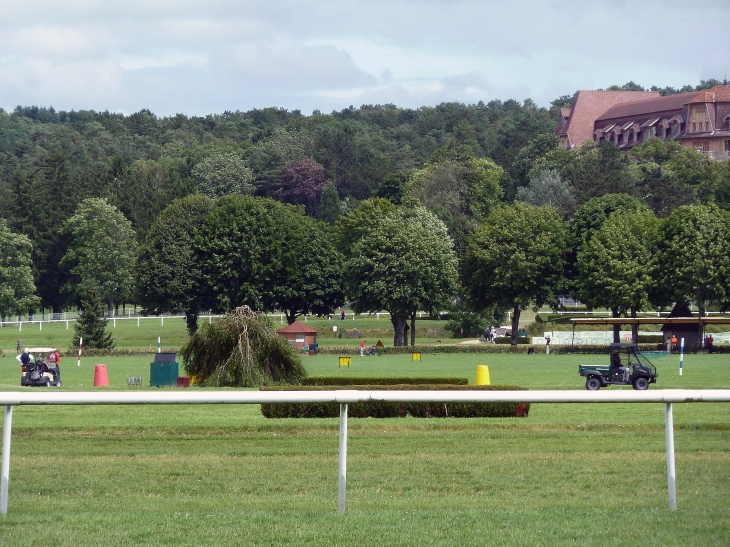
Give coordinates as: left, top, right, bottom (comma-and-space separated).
136, 195, 213, 335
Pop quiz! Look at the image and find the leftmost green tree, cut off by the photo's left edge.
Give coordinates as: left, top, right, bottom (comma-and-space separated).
0, 219, 41, 320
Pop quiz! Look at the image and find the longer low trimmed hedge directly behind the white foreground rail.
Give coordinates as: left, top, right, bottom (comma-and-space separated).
259, 384, 530, 418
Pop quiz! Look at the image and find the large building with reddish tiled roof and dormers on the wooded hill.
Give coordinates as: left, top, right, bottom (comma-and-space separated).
555, 85, 730, 160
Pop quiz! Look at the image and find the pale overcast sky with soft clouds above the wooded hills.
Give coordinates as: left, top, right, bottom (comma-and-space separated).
0, 0, 730, 116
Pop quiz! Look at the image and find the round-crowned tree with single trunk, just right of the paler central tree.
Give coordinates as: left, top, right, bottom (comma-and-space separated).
464, 202, 568, 344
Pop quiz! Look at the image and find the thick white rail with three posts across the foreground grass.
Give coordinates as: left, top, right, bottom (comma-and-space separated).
0, 389, 730, 515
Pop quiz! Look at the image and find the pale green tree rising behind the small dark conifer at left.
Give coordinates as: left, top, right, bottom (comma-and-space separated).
61, 198, 137, 309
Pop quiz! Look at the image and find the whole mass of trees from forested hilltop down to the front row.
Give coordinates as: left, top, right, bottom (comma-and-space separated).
0, 84, 730, 344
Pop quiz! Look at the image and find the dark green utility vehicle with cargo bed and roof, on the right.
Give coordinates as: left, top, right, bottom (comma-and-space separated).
578, 344, 658, 391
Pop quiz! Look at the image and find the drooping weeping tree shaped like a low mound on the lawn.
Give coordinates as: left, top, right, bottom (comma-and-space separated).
180, 306, 306, 387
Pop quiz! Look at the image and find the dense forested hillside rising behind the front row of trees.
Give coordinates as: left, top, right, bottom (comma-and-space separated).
0, 80, 730, 334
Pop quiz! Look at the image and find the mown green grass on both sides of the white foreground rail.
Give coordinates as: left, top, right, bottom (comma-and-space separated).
0, 348, 730, 547
